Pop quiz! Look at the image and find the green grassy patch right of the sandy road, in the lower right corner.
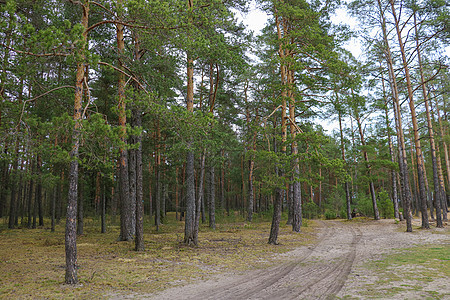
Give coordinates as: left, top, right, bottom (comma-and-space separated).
361, 244, 450, 299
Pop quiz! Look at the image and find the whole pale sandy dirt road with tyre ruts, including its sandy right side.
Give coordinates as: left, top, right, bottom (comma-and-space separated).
149, 220, 450, 300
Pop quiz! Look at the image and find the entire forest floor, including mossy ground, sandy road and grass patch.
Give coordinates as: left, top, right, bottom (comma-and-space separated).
0, 215, 450, 299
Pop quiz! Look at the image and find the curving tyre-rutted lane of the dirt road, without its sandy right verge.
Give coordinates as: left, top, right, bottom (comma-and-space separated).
154, 221, 362, 300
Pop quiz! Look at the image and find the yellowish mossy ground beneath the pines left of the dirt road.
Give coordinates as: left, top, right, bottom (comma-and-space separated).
0, 214, 314, 299
